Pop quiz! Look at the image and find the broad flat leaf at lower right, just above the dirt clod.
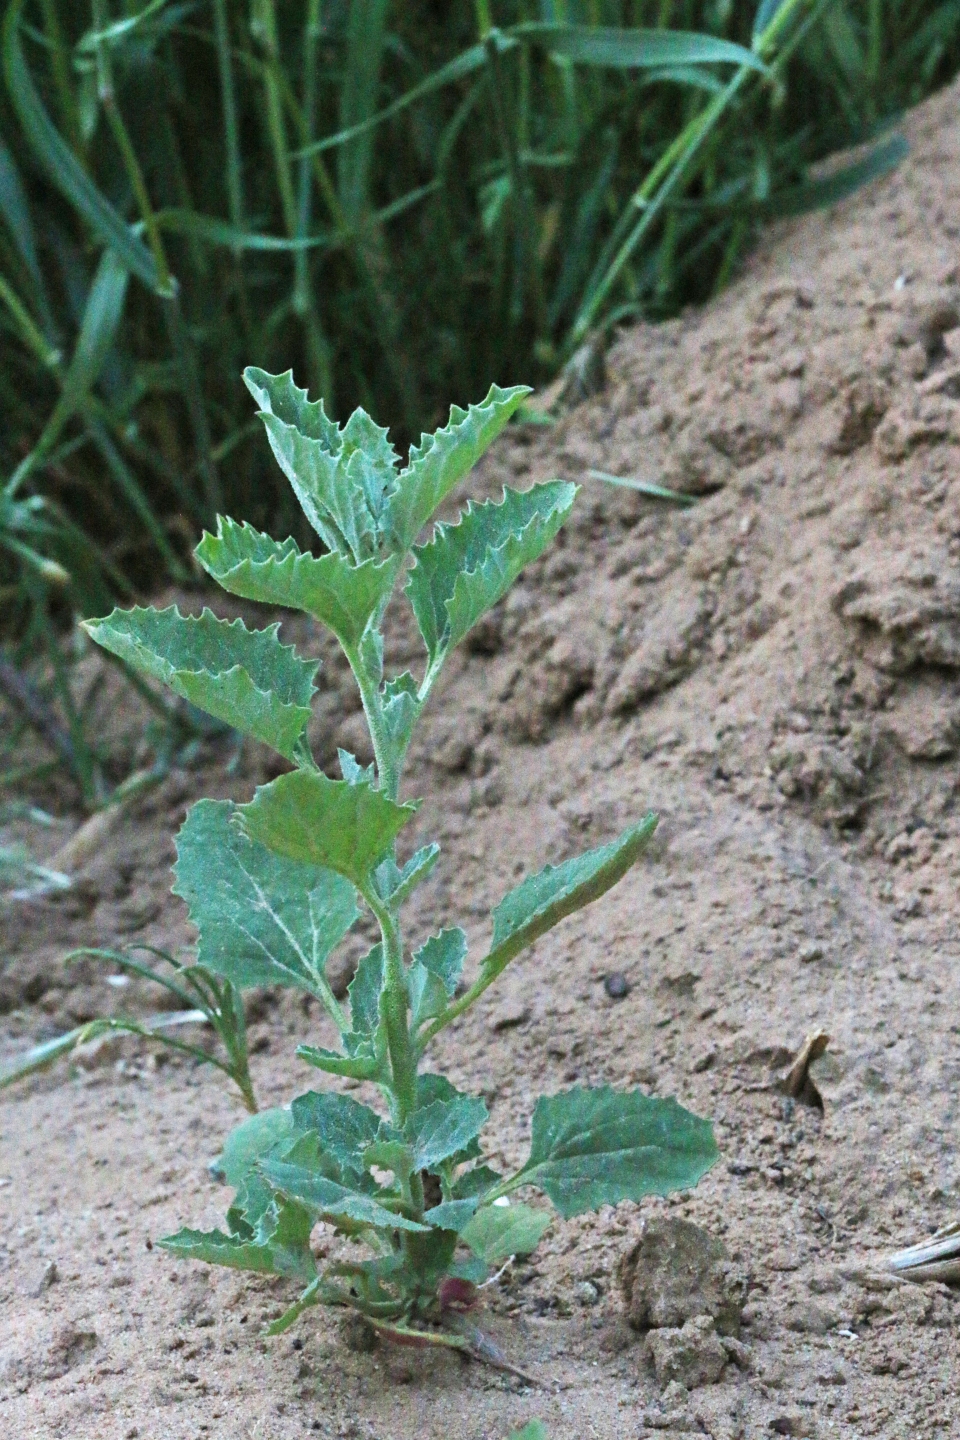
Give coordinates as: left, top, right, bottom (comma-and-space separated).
518, 1086, 717, 1218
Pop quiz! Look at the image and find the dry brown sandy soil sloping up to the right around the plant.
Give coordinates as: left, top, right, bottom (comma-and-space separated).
0, 73, 960, 1440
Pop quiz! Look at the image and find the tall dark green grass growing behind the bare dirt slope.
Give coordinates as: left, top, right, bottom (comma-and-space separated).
0, 0, 960, 794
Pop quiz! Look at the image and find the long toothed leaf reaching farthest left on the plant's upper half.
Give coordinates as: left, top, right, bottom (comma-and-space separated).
85, 605, 317, 759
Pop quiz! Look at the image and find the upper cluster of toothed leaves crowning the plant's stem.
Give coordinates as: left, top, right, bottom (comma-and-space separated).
88, 369, 576, 789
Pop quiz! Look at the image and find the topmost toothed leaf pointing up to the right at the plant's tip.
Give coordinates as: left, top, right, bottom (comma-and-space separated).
384, 384, 531, 550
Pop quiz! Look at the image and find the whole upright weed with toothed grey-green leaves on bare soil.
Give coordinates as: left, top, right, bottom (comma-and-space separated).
88, 370, 715, 1344
